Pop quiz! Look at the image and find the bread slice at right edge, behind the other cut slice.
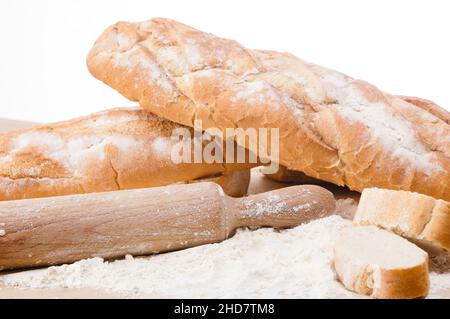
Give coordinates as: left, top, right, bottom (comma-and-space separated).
353, 188, 450, 255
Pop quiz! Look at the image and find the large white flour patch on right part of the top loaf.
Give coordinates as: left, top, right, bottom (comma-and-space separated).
311, 65, 443, 175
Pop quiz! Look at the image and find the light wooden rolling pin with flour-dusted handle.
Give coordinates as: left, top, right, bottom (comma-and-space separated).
0, 182, 335, 269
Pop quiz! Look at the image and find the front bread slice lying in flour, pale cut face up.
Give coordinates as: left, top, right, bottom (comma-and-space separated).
334, 226, 429, 299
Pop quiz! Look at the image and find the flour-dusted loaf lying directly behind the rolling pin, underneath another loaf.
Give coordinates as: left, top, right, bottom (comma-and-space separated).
0, 108, 256, 200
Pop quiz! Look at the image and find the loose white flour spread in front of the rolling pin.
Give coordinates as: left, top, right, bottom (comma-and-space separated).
0, 215, 450, 298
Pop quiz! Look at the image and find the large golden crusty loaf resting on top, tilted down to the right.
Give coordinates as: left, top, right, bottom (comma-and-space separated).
87, 19, 450, 200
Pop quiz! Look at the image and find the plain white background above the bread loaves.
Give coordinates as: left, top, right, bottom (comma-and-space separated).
0, 0, 450, 122
